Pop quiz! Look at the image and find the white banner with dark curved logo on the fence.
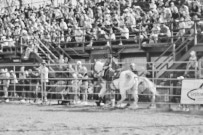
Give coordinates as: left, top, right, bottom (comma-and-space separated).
181, 79, 203, 104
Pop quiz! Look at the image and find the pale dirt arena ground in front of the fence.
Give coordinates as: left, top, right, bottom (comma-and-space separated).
0, 103, 203, 135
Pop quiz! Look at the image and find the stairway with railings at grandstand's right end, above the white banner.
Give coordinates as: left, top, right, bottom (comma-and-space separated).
154, 31, 203, 78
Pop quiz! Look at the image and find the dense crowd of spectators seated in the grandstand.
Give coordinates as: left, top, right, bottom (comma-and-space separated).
0, 0, 203, 51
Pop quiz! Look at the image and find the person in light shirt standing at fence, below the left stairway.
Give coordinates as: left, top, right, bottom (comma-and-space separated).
39, 60, 49, 102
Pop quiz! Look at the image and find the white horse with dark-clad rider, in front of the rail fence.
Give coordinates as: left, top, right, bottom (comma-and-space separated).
94, 61, 158, 108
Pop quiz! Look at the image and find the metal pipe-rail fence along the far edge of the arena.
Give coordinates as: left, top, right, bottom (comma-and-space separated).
0, 62, 202, 104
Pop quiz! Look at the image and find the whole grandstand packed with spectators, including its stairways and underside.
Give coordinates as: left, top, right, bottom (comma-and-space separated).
0, 0, 203, 103
